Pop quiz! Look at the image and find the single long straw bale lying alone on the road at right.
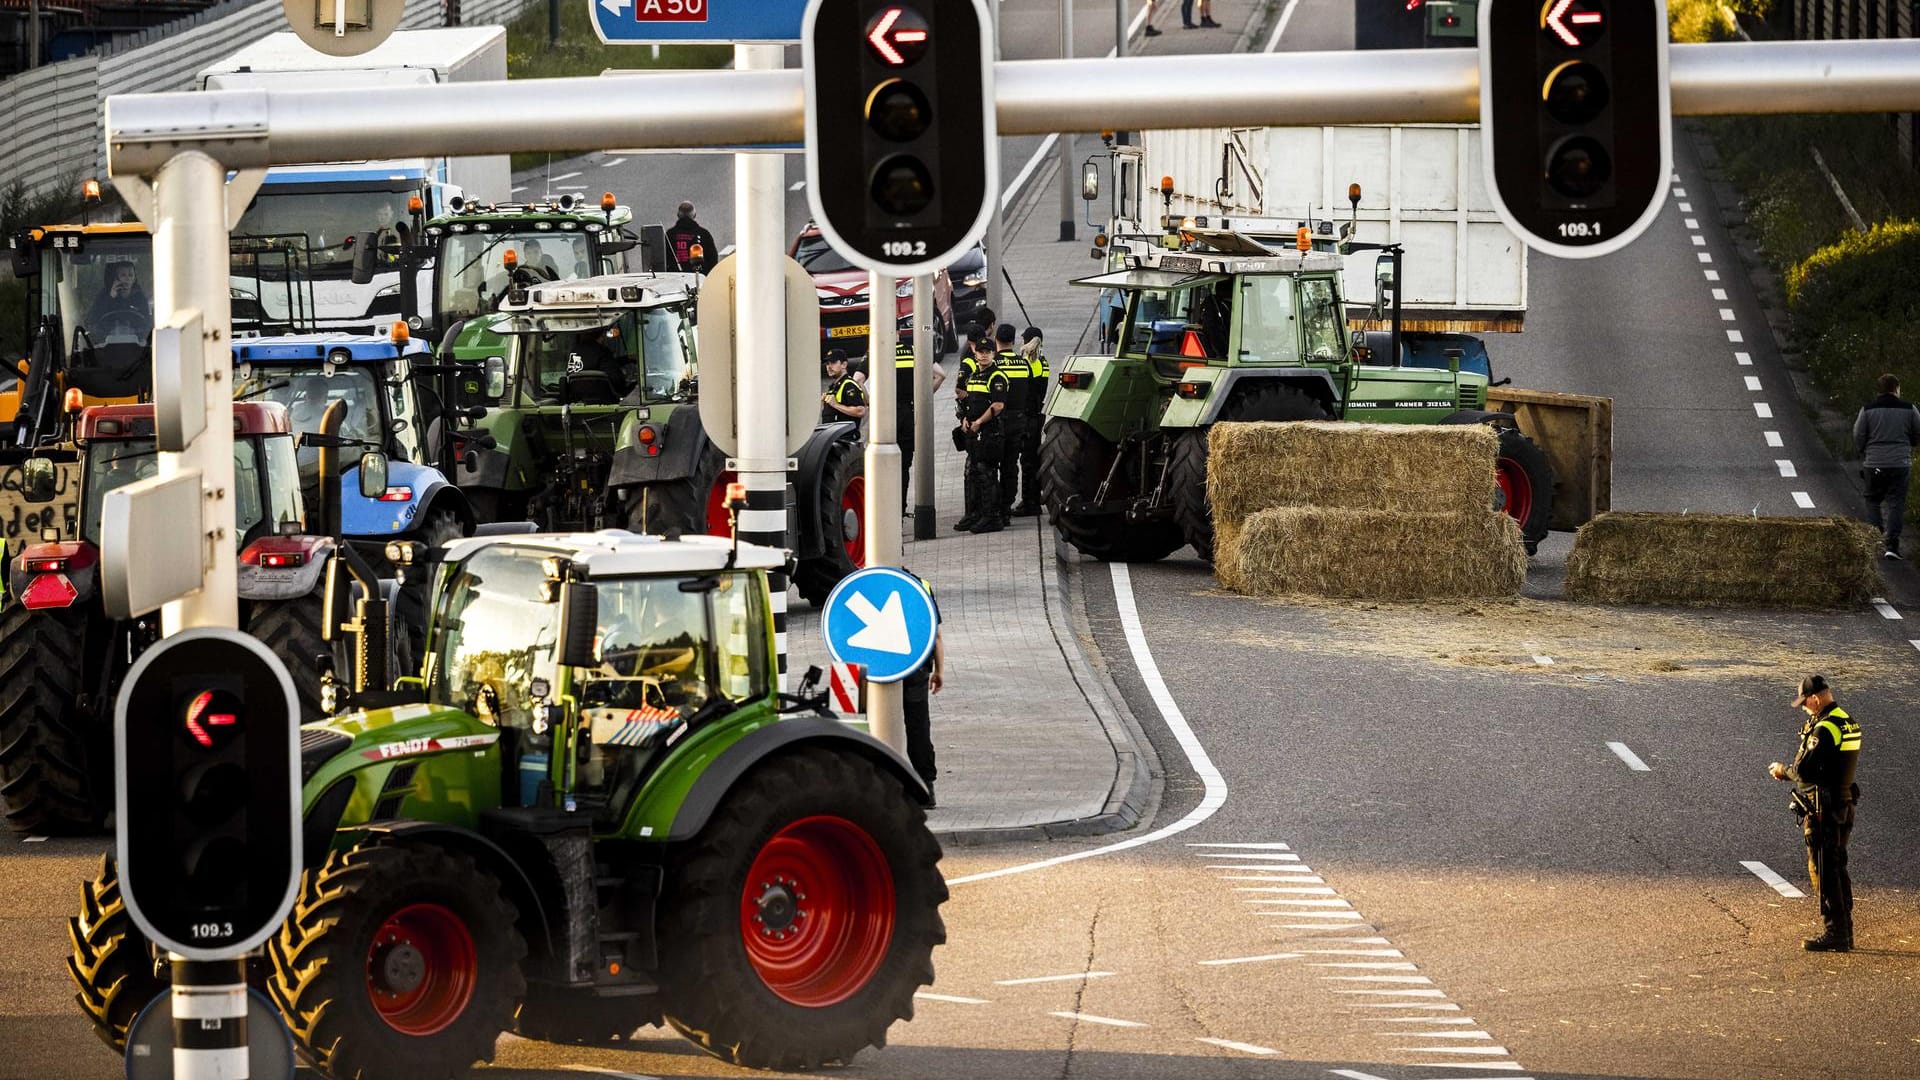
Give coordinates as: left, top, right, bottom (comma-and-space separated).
1567, 513, 1880, 607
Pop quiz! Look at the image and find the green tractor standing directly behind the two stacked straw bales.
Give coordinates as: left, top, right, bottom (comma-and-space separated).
1041, 223, 1553, 561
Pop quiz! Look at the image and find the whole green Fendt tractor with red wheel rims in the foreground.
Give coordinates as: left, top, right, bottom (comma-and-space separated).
71, 526, 947, 1080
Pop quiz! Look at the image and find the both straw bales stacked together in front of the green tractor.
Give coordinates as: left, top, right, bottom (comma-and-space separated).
1208, 421, 1526, 600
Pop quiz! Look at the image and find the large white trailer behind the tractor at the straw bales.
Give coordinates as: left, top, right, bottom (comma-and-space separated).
1114, 125, 1526, 332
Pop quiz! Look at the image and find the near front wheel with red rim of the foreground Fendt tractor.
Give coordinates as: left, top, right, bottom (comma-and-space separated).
267, 844, 526, 1080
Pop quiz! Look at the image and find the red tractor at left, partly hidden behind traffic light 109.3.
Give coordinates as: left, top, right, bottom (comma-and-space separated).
0, 403, 332, 834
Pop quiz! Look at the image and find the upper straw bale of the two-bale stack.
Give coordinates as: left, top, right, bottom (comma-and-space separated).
1206, 421, 1500, 528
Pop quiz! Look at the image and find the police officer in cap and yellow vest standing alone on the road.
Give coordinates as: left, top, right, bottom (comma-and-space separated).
1766, 675, 1860, 953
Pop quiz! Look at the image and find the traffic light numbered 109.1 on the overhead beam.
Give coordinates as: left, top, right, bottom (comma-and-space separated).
1480, 0, 1672, 258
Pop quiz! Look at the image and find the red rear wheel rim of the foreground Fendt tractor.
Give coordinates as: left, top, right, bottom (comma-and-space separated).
739, 817, 895, 1009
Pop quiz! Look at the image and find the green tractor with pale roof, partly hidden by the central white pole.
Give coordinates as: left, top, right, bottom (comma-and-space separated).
447, 273, 866, 603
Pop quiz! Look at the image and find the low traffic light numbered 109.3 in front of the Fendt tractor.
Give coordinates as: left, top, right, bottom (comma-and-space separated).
113, 628, 301, 959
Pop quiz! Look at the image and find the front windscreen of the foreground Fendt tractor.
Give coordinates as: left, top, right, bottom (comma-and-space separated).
426, 548, 561, 728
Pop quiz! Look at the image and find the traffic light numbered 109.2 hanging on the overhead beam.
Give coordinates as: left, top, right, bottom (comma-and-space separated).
801, 0, 1000, 277
